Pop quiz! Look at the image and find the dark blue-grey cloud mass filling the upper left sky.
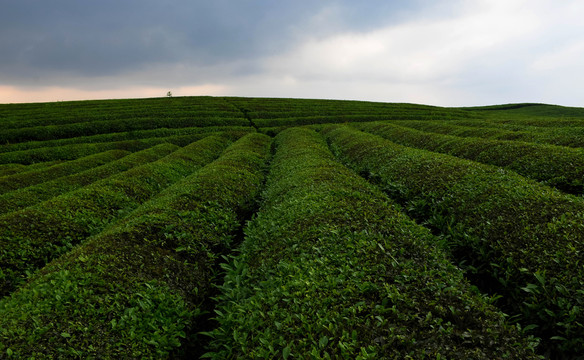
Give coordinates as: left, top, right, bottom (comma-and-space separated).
0, 0, 416, 83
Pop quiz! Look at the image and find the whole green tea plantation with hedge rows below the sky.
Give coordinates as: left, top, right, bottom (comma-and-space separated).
0, 97, 584, 359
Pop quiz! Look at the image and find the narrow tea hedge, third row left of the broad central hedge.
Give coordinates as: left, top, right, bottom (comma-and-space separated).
0, 143, 179, 214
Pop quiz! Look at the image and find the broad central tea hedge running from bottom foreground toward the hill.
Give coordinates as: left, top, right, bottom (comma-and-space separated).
204, 128, 538, 359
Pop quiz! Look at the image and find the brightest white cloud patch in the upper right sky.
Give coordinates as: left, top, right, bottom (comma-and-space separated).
266, 2, 534, 82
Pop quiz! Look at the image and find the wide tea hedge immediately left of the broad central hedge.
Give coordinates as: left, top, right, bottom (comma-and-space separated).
0, 134, 271, 359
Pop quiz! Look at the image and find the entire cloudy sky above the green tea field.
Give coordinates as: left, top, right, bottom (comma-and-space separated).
0, 0, 584, 107
